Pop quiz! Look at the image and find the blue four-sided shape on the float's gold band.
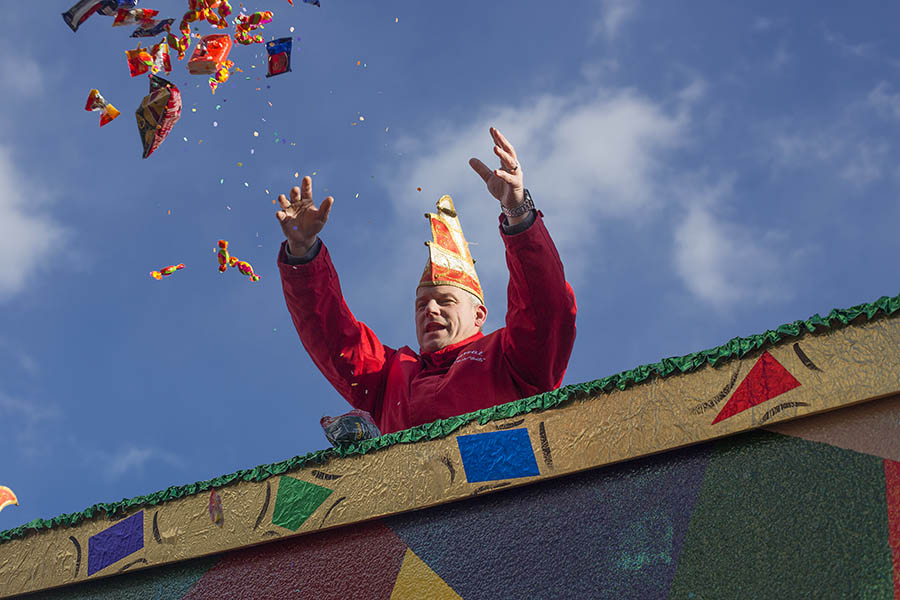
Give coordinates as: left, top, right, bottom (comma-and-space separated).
456, 428, 541, 483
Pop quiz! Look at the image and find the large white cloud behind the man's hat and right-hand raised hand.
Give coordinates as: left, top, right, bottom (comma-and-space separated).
382, 89, 687, 300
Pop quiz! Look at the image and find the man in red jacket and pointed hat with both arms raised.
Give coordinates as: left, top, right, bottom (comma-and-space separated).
276, 127, 575, 433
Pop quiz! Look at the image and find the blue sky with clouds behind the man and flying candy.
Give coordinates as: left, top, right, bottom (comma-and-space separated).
0, 0, 900, 529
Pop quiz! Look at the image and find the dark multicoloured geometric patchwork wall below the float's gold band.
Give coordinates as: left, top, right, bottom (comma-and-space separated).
29, 397, 900, 600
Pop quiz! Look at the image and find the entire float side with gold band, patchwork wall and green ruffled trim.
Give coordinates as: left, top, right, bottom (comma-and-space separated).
0, 299, 900, 599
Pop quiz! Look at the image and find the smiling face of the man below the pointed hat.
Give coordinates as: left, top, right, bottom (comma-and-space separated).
416, 285, 487, 352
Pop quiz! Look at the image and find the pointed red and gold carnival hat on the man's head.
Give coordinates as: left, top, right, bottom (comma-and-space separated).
418, 196, 484, 303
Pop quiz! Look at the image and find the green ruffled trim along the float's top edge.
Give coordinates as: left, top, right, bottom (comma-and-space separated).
0, 295, 900, 543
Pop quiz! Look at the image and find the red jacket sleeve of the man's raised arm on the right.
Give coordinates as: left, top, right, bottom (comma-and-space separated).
500, 211, 576, 396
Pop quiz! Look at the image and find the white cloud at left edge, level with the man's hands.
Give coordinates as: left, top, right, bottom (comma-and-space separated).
0, 145, 65, 302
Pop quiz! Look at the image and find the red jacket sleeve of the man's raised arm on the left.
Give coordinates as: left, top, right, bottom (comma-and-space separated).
278, 243, 395, 422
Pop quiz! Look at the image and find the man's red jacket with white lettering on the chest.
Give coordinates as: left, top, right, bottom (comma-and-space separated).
278, 212, 575, 433
